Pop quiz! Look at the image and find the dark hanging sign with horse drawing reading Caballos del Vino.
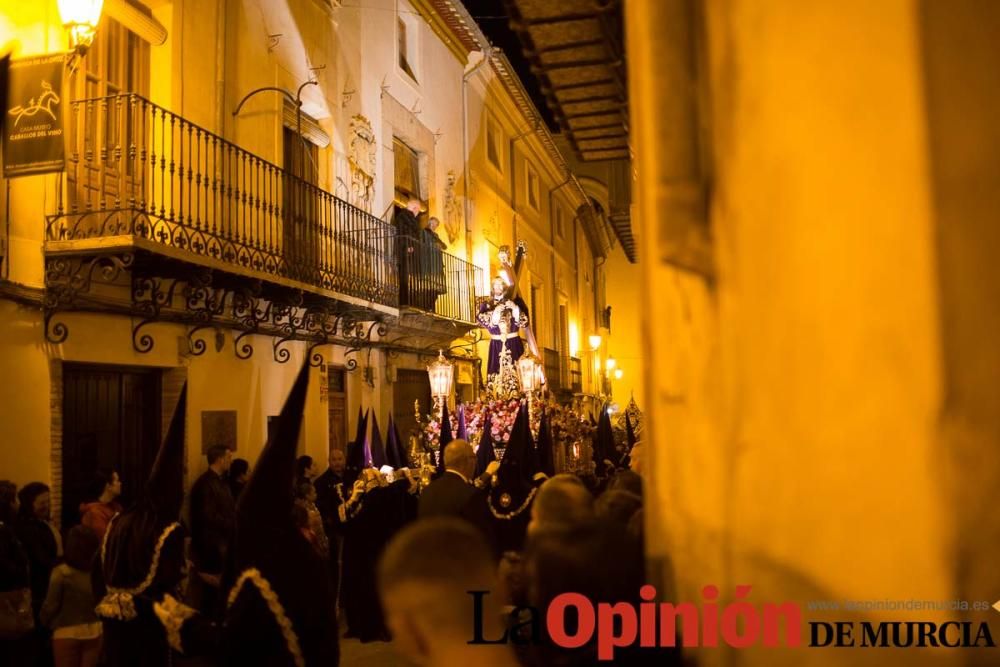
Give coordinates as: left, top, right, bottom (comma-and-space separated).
3, 53, 66, 178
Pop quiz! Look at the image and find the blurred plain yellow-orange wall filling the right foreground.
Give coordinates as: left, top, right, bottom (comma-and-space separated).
626, 0, 1000, 667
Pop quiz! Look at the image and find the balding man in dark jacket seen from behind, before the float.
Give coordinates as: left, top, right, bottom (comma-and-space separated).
417, 440, 496, 556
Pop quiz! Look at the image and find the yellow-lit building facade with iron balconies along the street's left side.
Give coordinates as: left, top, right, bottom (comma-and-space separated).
0, 0, 607, 522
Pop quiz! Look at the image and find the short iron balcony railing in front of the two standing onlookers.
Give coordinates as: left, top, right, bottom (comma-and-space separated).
396, 232, 483, 323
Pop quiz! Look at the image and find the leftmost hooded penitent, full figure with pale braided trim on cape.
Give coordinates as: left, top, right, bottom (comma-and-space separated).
92, 387, 187, 667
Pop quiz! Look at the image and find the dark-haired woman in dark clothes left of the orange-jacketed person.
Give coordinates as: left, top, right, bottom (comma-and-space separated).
14, 482, 62, 624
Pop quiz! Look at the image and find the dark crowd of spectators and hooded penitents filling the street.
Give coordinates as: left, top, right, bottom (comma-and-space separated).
0, 369, 677, 667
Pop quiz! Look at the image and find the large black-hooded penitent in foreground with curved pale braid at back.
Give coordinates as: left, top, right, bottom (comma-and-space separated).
223, 364, 339, 667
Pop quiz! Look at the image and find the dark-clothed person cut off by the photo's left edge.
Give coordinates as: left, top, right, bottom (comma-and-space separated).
0, 480, 35, 667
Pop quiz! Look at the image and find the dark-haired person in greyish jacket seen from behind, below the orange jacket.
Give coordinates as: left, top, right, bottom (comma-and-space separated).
40, 526, 101, 667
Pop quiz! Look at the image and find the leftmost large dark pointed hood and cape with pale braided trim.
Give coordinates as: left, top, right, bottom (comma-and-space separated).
95, 384, 187, 621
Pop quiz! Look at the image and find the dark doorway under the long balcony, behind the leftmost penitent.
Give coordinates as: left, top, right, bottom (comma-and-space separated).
61, 364, 162, 528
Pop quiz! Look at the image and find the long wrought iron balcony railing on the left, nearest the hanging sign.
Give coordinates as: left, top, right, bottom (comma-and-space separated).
46, 94, 398, 308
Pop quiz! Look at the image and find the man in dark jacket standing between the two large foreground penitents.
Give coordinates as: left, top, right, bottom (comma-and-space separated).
190, 445, 236, 617
